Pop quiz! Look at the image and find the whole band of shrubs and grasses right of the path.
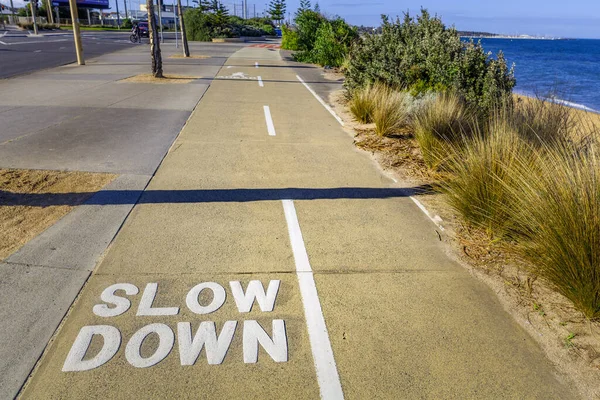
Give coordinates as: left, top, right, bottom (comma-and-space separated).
314, 9, 600, 320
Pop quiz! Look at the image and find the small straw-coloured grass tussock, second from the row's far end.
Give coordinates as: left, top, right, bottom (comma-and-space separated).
373, 86, 409, 136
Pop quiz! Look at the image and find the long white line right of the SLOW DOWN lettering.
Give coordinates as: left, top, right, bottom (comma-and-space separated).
282, 200, 344, 400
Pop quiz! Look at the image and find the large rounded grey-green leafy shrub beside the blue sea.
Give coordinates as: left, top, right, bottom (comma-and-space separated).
346, 10, 515, 112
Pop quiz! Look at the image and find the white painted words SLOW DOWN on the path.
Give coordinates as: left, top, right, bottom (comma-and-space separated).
62, 280, 288, 372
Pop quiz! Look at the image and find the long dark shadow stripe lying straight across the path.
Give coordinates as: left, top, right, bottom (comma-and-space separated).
0, 186, 431, 207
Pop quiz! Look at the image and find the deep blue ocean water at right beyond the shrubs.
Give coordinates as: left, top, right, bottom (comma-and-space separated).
474, 39, 600, 112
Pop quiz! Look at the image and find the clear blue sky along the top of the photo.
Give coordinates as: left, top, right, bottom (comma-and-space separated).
15, 0, 600, 38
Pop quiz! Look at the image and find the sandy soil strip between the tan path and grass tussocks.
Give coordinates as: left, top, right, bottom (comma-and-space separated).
330, 91, 600, 399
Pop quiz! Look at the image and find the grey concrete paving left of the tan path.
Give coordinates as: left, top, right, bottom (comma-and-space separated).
0, 39, 241, 399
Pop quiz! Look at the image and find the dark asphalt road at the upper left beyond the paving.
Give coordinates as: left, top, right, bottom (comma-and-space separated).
0, 30, 180, 79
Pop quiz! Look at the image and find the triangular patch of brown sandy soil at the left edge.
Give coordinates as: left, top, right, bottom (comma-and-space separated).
0, 169, 116, 260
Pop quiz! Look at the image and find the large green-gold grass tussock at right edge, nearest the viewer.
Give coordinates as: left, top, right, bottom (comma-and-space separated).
504, 143, 600, 319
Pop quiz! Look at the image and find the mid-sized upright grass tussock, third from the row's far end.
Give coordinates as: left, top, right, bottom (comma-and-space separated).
413, 94, 473, 170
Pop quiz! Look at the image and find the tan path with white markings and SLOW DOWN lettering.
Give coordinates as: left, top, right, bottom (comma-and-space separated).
16, 47, 577, 399
